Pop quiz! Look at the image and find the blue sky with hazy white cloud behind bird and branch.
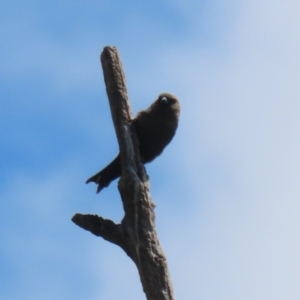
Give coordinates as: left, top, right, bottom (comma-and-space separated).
0, 0, 300, 300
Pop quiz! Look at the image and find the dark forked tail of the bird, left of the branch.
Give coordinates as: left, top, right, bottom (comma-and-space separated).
86, 155, 122, 193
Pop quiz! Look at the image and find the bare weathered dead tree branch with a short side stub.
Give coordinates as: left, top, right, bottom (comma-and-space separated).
72, 46, 174, 300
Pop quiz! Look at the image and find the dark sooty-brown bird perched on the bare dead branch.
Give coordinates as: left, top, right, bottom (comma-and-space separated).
86, 93, 180, 193
